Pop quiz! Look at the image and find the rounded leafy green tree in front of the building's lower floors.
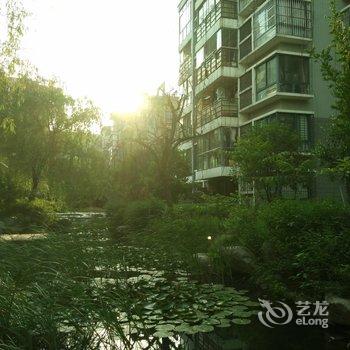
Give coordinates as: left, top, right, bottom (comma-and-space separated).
232, 123, 314, 202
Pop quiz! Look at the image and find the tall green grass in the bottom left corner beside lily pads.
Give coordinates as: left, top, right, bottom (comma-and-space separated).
0, 220, 170, 350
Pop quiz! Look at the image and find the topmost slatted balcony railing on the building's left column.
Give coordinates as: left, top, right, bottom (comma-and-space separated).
196, 0, 237, 42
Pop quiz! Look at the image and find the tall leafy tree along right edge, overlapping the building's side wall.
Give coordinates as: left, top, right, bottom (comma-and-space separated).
313, 0, 350, 200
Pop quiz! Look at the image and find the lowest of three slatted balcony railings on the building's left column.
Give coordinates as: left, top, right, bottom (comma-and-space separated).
198, 99, 238, 126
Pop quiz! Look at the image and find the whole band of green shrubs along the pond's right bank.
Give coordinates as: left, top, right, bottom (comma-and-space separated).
111, 197, 350, 299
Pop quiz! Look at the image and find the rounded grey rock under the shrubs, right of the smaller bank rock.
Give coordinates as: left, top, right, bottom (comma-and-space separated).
221, 246, 256, 274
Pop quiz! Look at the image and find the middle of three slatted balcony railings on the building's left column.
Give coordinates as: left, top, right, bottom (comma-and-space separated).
197, 47, 237, 84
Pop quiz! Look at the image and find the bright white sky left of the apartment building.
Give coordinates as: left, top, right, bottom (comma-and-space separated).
21, 0, 179, 123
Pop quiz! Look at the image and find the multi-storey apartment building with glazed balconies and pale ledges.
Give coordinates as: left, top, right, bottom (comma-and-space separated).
179, 0, 350, 197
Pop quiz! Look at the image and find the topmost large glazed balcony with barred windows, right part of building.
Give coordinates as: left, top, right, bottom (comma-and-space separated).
239, 0, 312, 65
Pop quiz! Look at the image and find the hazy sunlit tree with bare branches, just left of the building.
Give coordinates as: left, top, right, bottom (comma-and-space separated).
113, 92, 191, 204
